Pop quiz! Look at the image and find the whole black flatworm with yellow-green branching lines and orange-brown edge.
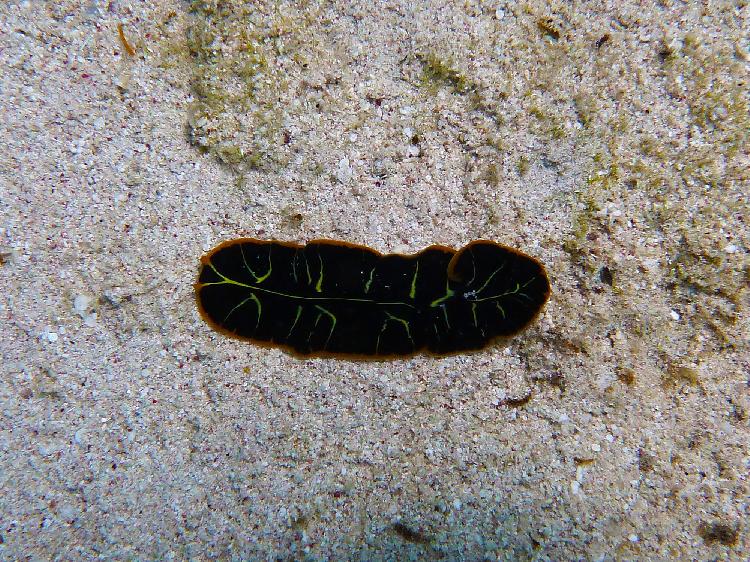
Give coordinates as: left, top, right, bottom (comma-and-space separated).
195, 238, 550, 359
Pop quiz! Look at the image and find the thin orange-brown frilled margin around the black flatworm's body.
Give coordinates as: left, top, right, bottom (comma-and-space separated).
193, 238, 550, 362
